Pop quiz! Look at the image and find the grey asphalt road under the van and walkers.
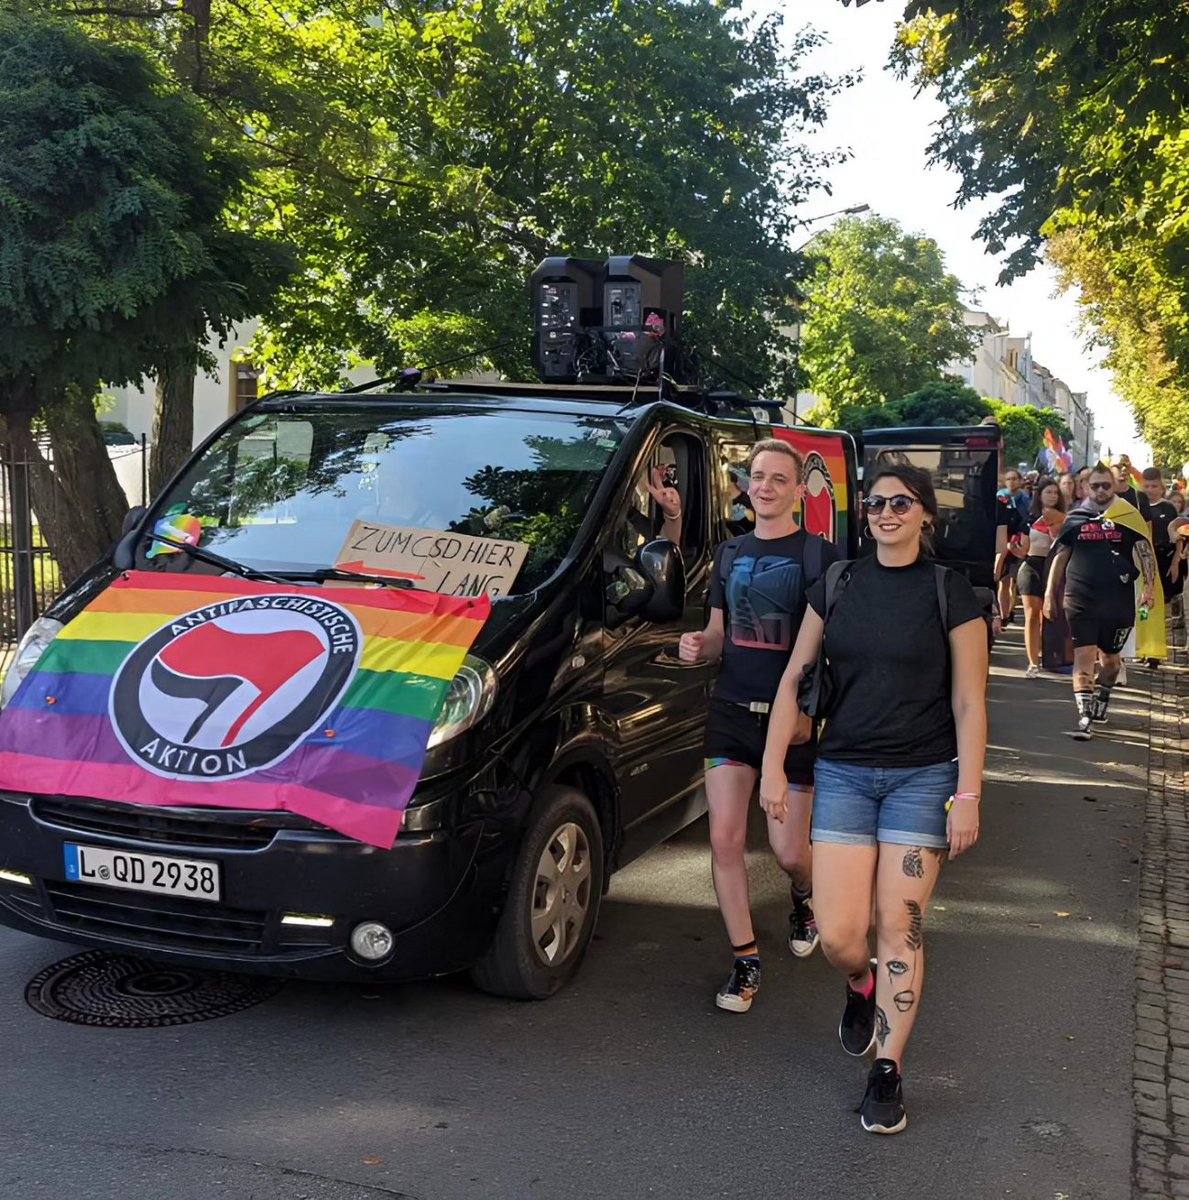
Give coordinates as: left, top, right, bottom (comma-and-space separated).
0, 634, 1147, 1200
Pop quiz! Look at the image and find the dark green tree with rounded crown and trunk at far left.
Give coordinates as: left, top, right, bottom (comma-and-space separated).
0, 12, 285, 578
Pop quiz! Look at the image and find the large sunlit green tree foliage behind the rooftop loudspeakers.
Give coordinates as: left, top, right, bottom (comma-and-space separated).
44, 0, 840, 398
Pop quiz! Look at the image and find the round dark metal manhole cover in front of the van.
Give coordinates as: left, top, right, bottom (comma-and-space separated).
25, 950, 281, 1030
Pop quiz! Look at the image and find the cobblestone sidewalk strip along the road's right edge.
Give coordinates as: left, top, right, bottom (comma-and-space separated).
1133, 634, 1189, 1200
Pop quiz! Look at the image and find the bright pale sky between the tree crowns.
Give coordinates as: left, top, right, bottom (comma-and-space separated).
772, 0, 1151, 466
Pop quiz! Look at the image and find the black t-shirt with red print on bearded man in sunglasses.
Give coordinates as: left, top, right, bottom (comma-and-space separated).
1053, 509, 1146, 628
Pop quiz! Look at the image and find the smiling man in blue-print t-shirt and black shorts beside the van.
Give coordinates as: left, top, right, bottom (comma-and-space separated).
679, 438, 839, 1013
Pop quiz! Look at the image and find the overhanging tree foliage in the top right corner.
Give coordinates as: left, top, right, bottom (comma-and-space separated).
895, 0, 1189, 461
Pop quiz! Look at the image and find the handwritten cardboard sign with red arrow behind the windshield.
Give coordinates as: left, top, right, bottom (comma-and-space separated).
335, 521, 529, 596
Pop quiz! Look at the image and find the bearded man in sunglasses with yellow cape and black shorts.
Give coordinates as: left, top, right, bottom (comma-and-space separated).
1044, 464, 1155, 740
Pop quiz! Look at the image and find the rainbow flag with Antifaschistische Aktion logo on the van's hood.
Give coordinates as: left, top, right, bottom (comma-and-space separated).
0, 571, 491, 847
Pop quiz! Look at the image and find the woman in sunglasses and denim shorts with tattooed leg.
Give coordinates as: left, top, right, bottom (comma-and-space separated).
761, 464, 987, 1134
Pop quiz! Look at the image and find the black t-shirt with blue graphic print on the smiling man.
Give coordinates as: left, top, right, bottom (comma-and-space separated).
710, 529, 839, 704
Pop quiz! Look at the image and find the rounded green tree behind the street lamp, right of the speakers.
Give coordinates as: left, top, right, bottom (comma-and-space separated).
800, 216, 975, 425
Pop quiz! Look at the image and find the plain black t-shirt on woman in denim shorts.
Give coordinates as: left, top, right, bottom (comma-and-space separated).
809, 554, 983, 767
